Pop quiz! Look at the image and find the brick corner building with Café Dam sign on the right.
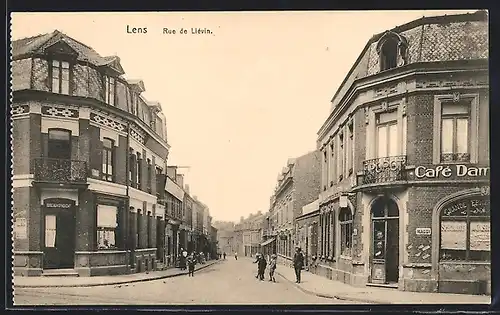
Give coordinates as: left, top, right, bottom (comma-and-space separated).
316, 11, 491, 294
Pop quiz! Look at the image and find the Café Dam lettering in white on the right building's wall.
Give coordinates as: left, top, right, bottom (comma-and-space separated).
415, 164, 490, 179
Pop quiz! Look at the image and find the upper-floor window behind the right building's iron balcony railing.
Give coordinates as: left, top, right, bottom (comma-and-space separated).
375, 111, 398, 158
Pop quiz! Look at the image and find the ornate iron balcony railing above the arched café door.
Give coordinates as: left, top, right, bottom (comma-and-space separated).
362, 155, 406, 184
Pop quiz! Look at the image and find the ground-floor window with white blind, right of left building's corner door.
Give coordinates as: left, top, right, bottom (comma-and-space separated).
97, 205, 118, 249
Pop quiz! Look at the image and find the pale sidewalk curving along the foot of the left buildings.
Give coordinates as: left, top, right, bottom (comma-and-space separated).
13, 260, 221, 288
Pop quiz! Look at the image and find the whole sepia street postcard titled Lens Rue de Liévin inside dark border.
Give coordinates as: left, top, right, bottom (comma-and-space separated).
9, 9, 491, 309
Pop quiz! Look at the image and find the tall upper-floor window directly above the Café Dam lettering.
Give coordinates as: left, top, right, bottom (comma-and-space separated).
441, 103, 470, 163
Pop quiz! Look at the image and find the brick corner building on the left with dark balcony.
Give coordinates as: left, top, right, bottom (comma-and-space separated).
12, 30, 169, 276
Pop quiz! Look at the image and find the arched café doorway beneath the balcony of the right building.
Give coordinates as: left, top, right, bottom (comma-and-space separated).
371, 197, 399, 284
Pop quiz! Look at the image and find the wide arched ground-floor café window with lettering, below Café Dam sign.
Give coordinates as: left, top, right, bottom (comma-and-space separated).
439, 196, 491, 261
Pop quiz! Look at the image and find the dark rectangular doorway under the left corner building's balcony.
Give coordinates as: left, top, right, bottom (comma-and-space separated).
42, 203, 76, 269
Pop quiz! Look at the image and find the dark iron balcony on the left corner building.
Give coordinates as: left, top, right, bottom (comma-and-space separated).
34, 157, 87, 184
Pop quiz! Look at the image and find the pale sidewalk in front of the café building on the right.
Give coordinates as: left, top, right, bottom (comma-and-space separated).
276, 265, 491, 304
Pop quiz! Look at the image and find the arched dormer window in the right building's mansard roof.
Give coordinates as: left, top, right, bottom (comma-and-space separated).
377, 32, 408, 71
